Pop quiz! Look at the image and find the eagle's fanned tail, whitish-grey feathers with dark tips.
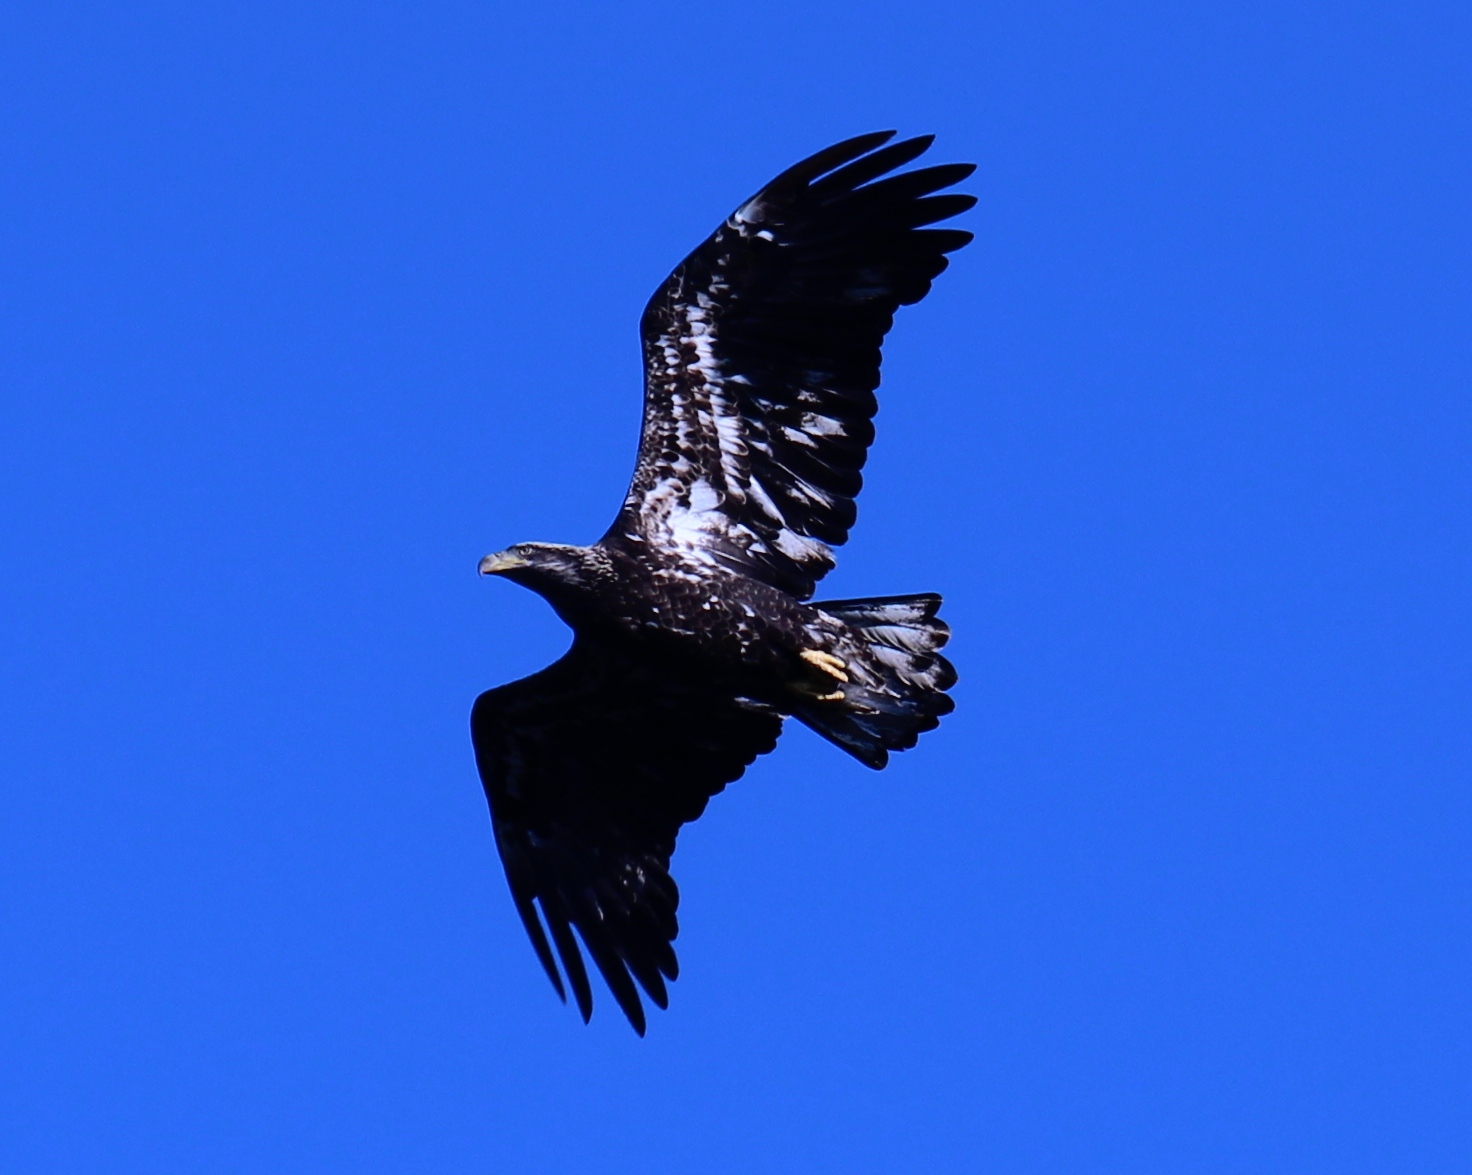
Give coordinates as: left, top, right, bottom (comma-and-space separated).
795, 593, 955, 770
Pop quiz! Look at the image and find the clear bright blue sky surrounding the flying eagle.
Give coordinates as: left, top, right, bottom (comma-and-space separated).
0, 0, 1472, 1175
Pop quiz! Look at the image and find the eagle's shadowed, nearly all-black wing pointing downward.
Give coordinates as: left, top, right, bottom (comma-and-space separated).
471, 636, 782, 1035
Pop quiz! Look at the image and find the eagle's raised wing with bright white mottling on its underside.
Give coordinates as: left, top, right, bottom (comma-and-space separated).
609, 131, 976, 599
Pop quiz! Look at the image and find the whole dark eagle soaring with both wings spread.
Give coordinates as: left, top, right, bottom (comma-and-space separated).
471, 131, 976, 1035
